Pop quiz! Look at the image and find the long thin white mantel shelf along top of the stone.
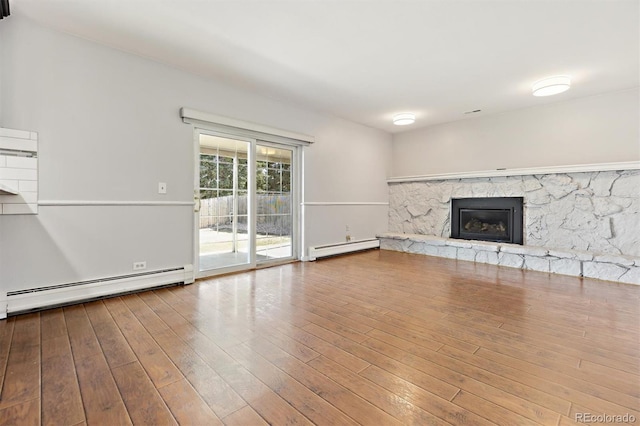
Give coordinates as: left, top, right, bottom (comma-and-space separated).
387, 161, 640, 183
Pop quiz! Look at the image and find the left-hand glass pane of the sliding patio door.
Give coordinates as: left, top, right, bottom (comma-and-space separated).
198, 134, 251, 271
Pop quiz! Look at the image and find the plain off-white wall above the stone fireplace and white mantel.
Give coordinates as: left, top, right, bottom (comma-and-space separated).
392, 88, 640, 176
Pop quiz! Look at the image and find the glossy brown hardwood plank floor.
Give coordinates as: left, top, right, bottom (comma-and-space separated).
0, 250, 640, 425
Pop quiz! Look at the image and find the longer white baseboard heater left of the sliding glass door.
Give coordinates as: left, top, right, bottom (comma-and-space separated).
0, 265, 194, 319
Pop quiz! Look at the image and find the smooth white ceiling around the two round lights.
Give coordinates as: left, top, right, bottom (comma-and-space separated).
11, 0, 640, 132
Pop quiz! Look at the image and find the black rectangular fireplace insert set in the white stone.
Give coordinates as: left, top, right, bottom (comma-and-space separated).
451, 197, 523, 244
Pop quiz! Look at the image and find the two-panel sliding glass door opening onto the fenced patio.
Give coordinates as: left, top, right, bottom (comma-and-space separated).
195, 131, 297, 276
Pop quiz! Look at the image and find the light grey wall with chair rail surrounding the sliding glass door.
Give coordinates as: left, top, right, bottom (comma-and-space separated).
0, 15, 391, 291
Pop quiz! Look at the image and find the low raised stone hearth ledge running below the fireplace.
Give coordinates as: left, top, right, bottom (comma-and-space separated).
376, 233, 640, 285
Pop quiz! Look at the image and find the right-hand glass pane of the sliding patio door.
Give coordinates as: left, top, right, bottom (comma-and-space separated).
256, 144, 294, 263
